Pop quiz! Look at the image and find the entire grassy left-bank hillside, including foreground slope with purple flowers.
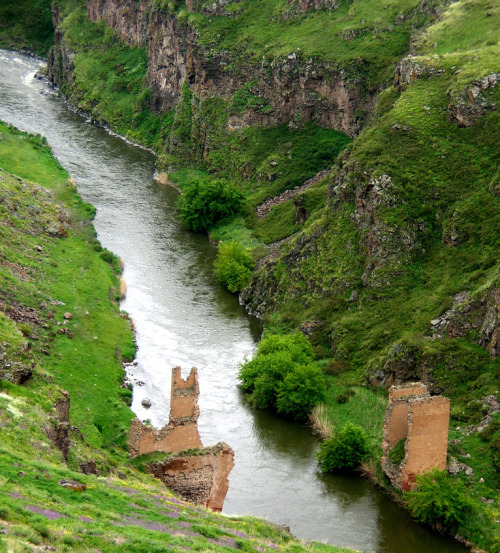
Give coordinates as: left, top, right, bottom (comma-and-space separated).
0, 124, 352, 553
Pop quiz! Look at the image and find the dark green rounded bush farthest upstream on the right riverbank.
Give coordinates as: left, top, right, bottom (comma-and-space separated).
177, 178, 243, 232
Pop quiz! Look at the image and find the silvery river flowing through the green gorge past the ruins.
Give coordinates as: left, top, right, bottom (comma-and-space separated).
0, 50, 464, 553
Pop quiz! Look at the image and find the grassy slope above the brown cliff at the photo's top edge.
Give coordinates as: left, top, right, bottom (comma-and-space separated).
188, 0, 421, 84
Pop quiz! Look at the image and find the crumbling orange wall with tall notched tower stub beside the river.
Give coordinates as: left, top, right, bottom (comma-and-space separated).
129, 367, 203, 457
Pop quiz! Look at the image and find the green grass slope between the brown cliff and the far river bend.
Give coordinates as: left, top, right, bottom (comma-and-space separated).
52, 2, 350, 249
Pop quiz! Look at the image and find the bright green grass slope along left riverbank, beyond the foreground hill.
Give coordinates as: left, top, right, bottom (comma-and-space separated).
0, 125, 134, 445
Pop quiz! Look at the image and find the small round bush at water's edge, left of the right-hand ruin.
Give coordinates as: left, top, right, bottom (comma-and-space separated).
317, 423, 369, 472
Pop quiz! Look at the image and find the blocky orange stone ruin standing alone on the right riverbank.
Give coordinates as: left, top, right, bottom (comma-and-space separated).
381, 383, 450, 490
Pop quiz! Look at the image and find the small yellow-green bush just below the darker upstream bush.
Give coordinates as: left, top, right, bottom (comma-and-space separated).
214, 241, 255, 292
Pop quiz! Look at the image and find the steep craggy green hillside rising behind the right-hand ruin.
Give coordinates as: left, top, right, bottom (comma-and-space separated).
240, 1, 500, 551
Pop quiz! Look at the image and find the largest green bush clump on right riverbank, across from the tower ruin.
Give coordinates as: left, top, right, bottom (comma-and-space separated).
239, 333, 326, 420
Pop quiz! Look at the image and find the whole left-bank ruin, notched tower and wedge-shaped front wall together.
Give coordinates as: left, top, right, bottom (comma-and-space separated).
129, 367, 234, 511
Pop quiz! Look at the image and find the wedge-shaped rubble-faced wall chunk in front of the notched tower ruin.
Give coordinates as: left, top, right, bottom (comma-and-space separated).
150, 442, 234, 511
